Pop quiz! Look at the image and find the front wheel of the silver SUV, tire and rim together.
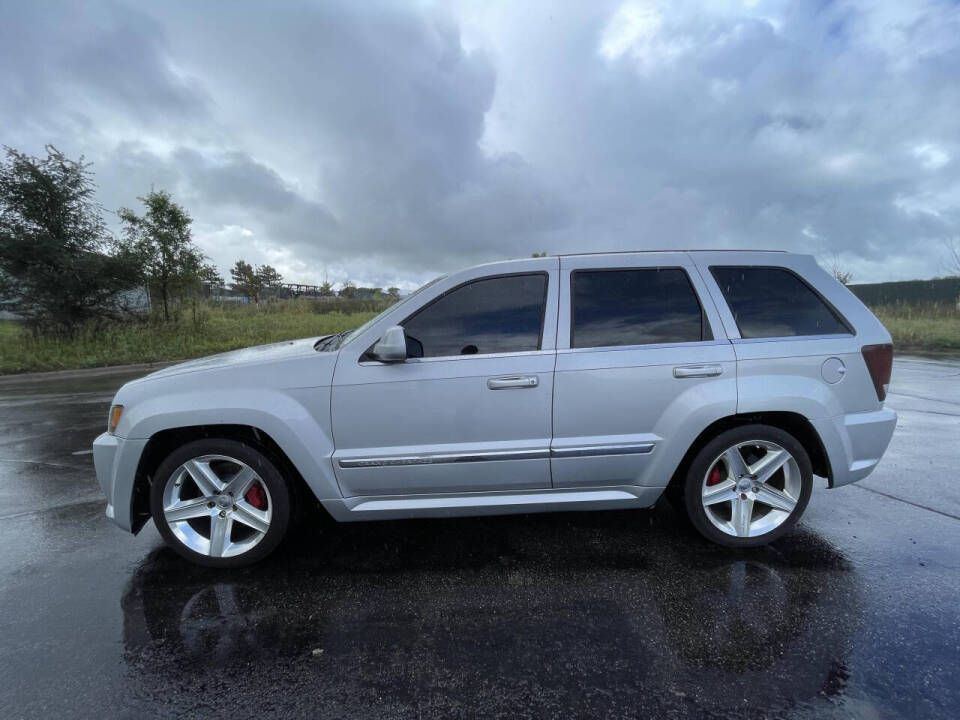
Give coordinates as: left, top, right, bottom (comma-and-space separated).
150, 439, 290, 567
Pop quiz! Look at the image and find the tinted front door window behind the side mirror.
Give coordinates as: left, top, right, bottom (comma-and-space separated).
403, 273, 547, 357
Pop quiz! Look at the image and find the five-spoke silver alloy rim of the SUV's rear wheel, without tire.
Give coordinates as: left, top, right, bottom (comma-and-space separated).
700, 440, 803, 537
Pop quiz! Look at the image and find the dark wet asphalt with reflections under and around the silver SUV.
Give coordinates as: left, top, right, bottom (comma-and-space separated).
0, 358, 960, 718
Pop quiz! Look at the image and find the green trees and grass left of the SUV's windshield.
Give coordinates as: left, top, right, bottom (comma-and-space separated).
0, 146, 400, 373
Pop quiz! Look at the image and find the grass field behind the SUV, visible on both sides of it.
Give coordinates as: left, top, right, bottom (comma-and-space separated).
0, 299, 960, 374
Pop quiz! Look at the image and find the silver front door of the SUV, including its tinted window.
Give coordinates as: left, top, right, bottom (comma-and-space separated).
331, 258, 559, 497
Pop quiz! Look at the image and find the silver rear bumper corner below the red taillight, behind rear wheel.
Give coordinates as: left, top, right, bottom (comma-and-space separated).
813, 408, 897, 487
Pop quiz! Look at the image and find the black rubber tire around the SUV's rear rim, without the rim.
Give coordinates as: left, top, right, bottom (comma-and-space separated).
683, 425, 813, 548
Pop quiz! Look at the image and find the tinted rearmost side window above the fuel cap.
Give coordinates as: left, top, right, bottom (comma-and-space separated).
710, 267, 850, 338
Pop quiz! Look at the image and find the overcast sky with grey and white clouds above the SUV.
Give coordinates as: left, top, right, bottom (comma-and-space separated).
0, 0, 960, 288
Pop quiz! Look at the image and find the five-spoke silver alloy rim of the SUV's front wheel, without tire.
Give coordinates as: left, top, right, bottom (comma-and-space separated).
163, 455, 273, 557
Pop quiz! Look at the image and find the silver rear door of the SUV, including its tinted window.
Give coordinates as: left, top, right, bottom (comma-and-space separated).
551, 253, 736, 487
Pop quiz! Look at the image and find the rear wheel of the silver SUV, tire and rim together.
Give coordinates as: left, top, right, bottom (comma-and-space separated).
684, 425, 813, 547
